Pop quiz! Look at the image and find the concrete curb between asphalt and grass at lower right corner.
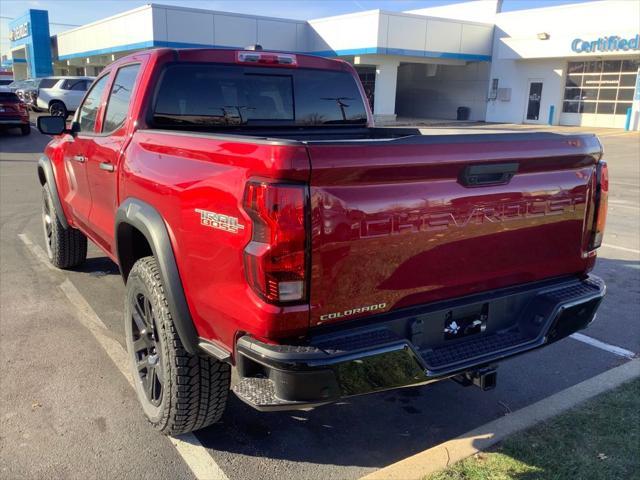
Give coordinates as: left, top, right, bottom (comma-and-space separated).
361, 359, 640, 480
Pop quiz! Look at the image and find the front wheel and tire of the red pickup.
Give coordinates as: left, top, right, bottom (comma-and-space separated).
42, 184, 87, 268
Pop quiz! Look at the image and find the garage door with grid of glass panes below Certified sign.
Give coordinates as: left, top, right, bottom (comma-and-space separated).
561, 60, 640, 127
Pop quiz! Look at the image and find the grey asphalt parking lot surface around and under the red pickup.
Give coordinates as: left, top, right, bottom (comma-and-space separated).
0, 117, 640, 480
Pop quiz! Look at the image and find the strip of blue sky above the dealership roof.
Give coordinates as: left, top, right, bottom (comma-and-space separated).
0, 0, 589, 55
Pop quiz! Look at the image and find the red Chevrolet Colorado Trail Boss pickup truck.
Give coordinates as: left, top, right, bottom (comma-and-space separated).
38, 48, 608, 434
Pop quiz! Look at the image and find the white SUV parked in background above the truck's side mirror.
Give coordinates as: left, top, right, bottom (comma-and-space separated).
32, 77, 93, 117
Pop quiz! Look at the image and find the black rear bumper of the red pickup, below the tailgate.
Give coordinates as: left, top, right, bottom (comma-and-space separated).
233, 275, 605, 410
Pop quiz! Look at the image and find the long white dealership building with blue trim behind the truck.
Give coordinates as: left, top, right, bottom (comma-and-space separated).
9, 0, 640, 130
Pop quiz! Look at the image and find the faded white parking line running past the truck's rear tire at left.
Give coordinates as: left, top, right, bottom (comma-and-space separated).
18, 233, 229, 480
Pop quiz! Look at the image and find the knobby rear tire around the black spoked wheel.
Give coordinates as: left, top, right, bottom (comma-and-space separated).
124, 257, 231, 435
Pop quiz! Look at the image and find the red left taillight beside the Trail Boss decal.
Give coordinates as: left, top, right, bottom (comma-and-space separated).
244, 181, 307, 303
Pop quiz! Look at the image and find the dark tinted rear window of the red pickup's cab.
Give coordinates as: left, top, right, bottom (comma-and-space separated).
153, 64, 367, 128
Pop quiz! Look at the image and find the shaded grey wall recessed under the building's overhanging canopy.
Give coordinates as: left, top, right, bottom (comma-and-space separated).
396, 62, 490, 121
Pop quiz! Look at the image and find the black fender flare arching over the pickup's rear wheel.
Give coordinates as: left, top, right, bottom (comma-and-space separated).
115, 198, 199, 355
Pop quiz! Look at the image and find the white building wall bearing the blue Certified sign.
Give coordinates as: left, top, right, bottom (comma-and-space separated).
486, 0, 640, 127
